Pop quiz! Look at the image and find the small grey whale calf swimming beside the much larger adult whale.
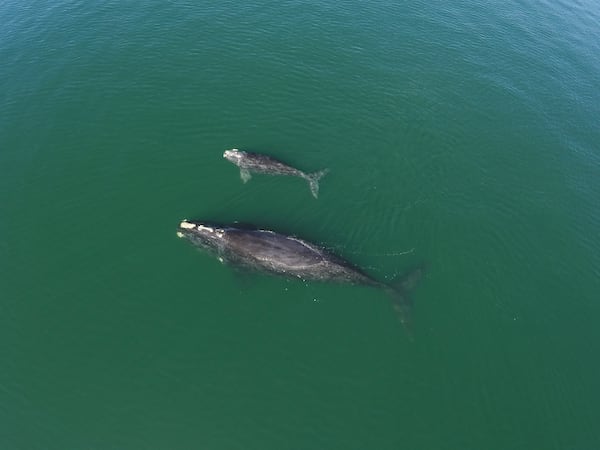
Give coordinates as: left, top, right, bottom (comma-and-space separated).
223, 148, 329, 198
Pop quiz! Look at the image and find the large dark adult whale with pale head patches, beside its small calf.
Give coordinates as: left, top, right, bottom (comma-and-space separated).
177, 220, 423, 329
